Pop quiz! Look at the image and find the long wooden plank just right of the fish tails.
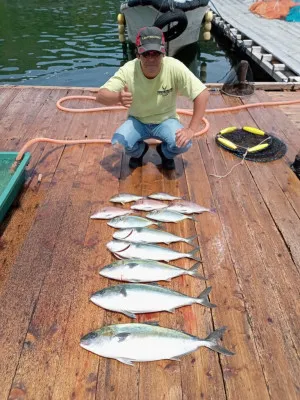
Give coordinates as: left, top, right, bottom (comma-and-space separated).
178, 95, 269, 399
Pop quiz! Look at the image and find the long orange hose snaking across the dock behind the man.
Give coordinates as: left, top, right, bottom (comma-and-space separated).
12, 96, 300, 168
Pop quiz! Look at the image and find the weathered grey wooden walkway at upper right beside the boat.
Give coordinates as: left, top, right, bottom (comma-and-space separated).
211, 0, 300, 82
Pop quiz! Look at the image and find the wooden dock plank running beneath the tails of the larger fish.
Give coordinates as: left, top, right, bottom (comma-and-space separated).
149, 104, 226, 399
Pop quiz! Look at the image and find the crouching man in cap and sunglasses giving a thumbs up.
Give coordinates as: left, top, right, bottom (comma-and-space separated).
96, 27, 209, 170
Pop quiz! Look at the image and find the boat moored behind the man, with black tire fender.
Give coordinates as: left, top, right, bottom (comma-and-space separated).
120, 0, 209, 57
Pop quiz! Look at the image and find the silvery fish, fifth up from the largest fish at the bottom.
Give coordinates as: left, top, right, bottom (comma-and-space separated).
113, 228, 198, 244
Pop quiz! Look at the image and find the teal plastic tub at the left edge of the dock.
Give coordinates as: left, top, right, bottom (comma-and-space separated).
0, 152, 30, 222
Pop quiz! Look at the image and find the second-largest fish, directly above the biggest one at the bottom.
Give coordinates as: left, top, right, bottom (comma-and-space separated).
91, 283, 216, 318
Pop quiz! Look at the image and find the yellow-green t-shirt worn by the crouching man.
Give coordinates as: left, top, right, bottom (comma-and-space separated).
101, 57, 206, 124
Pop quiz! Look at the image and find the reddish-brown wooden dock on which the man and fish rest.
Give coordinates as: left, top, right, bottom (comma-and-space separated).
0, 87, 300, 400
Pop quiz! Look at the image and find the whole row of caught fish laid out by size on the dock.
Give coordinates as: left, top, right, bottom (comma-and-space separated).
80, 193, 234, 365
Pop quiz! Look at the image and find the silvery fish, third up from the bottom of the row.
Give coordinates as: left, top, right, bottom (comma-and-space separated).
99, 258, 206, 282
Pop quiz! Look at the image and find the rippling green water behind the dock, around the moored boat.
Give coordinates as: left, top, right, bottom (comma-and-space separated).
0, 0, 270, 87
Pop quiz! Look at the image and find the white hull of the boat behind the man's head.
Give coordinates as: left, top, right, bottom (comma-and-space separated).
122, 6, 208, 57
